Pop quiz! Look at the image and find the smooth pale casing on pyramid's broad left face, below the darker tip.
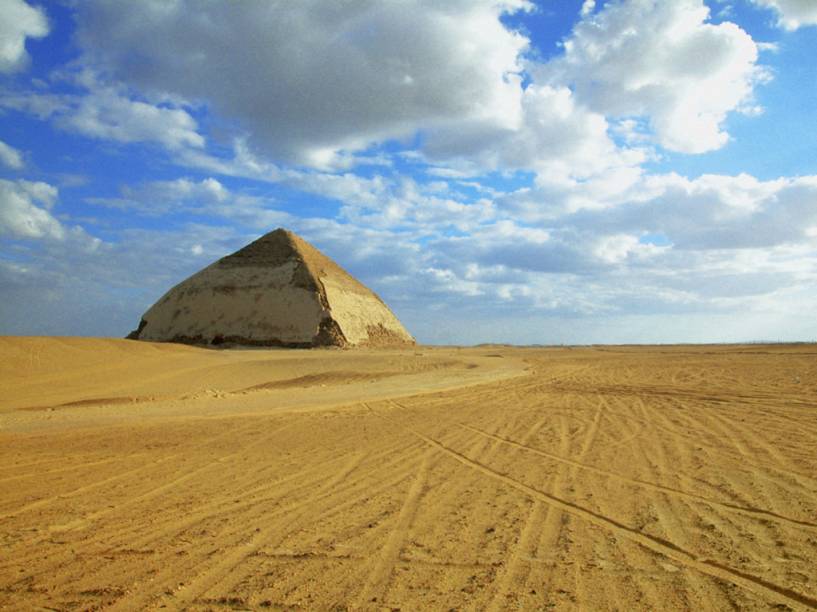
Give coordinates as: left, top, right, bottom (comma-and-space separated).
138, 259, 332, 347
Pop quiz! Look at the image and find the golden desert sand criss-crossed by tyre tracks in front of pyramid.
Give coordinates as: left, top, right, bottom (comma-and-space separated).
0, 337, 817, 610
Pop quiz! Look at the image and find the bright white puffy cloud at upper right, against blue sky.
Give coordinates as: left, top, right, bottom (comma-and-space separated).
539, 0, 765, 153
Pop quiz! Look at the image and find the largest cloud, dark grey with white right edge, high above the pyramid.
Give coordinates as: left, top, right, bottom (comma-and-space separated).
78, 0, 528, 168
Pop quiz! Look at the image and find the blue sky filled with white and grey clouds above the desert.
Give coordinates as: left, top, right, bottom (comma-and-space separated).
0, 0, 817, 344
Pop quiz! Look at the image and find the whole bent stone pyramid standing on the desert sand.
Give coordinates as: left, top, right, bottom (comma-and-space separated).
128, 229, 414, 347
